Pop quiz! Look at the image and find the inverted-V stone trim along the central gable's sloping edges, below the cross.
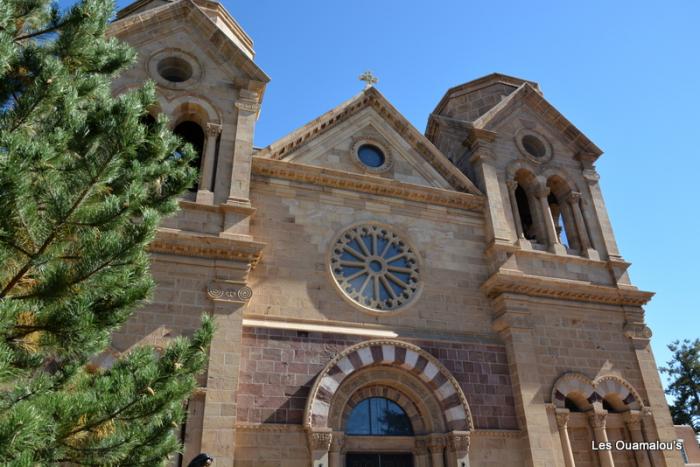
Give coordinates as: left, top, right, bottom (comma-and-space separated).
257, 87, 482, 195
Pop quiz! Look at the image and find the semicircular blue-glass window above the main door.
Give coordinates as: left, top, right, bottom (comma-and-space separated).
345, 397, 413, 436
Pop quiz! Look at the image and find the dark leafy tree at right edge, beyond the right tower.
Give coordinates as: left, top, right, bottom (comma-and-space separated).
661, 339, 700, 433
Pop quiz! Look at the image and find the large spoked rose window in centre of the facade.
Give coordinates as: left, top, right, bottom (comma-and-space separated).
330, 224, 420, 312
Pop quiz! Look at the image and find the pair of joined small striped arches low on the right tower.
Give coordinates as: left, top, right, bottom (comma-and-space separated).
551, 372, 644, 412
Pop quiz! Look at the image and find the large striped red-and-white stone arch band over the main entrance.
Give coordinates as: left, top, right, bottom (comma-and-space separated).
304, 340, 473, 431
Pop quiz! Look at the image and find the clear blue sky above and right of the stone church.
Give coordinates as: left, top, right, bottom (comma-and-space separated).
61, 0, 700, 384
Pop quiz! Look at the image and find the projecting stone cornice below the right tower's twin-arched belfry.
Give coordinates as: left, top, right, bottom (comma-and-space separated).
481, 271, 654, 306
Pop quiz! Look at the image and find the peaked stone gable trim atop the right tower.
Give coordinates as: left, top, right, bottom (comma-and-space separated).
472, 82, 603, 157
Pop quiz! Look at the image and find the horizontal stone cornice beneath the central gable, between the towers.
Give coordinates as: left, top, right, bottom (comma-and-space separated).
253, 156, 484, 211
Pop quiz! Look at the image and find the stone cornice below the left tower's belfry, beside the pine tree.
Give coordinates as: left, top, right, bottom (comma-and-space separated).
149, 228, 265, 267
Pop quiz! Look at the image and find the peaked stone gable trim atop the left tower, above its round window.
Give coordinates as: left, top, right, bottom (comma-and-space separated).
108, 0, 270, 83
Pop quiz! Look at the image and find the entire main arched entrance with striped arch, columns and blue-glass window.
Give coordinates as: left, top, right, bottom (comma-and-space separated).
305, 341, 472, 467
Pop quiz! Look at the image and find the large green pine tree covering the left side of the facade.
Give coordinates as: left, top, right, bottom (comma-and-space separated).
0, 0, 213, 466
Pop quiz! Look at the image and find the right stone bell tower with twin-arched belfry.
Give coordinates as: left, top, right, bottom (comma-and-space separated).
426, 74, 679, 466
